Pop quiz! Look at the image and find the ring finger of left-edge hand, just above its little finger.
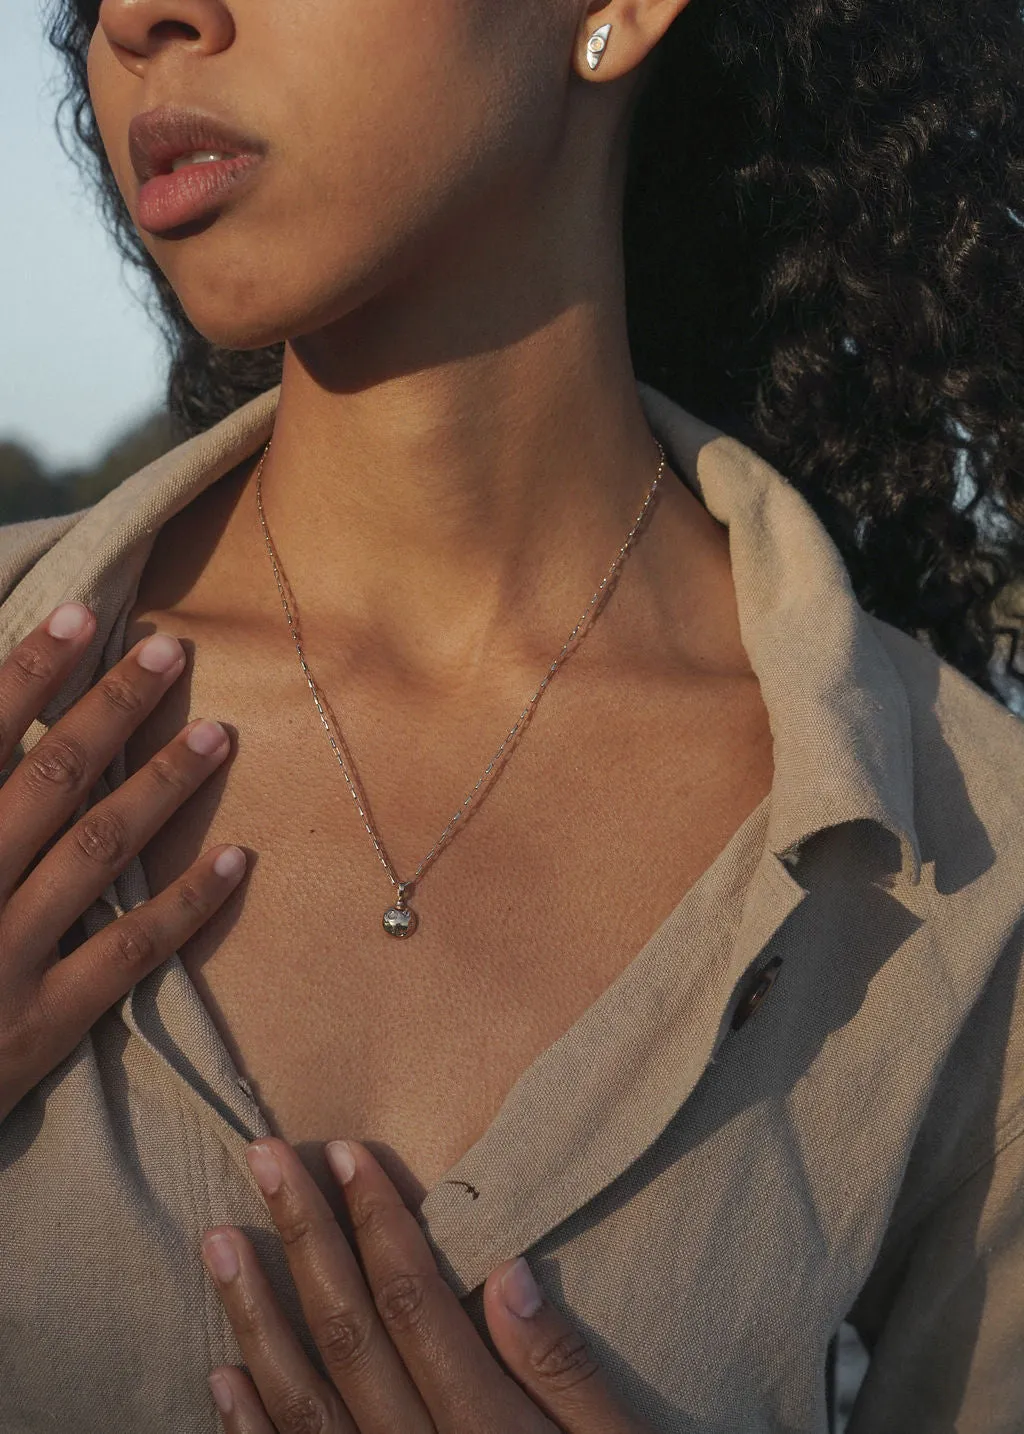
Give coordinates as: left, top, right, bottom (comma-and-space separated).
1, 721, 231, 965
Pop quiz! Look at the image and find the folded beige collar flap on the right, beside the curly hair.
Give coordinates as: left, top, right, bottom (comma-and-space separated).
640, 384, 921, 885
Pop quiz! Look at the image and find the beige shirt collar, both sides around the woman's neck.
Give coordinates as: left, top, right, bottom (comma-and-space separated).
0, 383, 921, 883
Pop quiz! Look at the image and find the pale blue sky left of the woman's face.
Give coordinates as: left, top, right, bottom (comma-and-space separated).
0, 0, 163, 466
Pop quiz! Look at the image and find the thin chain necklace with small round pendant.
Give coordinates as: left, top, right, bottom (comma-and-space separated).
255, 437, 665, 936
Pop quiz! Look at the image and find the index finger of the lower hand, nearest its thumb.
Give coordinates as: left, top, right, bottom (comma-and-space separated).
326, 1140, 551, 1434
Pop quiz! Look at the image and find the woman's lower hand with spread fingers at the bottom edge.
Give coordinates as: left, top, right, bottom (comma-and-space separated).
202, 1139, 653, 1434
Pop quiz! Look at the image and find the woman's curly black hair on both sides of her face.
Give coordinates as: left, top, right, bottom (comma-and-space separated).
43, 0, 1024, 710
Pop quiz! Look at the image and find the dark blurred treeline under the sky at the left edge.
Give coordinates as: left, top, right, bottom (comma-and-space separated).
0, 409, 174, 523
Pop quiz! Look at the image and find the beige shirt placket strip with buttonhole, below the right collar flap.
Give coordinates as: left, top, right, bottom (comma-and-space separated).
419, 825, 807, 1296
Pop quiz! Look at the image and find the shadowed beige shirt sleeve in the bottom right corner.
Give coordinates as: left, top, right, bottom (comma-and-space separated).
846, 1110, 1024, 1434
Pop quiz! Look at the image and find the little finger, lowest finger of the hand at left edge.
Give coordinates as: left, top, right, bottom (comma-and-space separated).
10, 846, 245, 1098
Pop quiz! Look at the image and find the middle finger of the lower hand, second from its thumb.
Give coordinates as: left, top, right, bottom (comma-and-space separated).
245, 1140, 433, 1434
